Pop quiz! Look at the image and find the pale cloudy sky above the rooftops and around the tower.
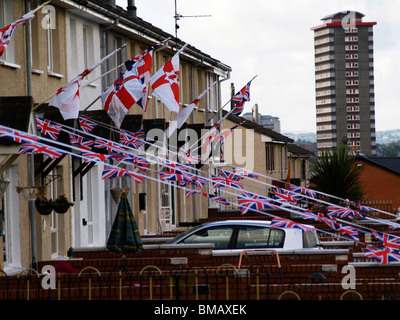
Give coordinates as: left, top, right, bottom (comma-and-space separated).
116, 0, 400, 133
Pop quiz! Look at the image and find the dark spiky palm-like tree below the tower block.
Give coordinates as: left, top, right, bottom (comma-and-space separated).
309, 144, 365, 202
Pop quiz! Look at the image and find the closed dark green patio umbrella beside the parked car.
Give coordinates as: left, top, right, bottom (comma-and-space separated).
107, 192, 143, 258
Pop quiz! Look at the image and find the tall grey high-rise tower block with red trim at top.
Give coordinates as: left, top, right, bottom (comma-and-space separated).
311, 11, 376, 155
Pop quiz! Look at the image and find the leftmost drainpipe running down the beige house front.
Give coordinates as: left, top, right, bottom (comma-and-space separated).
25, 0, 37, 270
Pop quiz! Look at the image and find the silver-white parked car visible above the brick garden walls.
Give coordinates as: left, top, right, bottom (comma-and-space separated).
167, 220, 321, 251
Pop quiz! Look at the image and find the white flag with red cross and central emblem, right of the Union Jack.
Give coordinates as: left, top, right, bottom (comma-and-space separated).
150, 44, 187, 112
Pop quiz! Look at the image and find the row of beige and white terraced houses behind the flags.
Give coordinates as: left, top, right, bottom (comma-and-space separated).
0, 0, 309, 274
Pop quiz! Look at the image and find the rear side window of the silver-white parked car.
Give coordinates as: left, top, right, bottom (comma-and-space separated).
236, 226, 285, 249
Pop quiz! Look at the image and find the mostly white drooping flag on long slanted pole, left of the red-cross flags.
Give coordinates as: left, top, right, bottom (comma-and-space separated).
49, 44, 126, 120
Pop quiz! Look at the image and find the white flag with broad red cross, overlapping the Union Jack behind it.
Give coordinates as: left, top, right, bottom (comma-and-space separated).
101, 63, 145, 128
